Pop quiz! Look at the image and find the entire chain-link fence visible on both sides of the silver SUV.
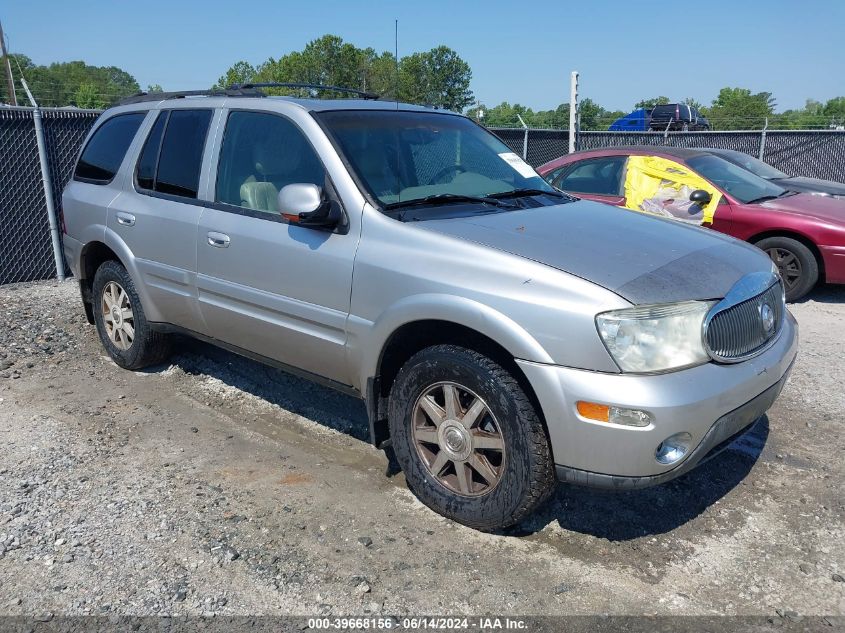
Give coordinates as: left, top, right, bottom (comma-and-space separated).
0, 108, 845, 284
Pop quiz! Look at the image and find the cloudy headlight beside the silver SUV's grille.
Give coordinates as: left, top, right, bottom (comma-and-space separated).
596, 301, 716, 373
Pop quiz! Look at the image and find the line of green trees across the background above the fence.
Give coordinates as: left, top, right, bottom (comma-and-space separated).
0, 34, 845, 130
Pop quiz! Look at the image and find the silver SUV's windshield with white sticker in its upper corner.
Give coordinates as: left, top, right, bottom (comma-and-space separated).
317, 110, 562, 210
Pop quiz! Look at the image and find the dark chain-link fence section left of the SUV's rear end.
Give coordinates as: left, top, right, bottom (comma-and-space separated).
0, 108, 99, 284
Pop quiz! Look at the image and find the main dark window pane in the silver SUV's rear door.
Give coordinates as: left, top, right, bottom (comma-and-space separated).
155, 110, 212, 198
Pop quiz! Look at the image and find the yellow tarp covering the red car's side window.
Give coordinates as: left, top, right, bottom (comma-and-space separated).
625, 156, 722, 224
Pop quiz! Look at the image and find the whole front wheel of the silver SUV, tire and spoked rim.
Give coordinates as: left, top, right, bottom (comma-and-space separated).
388, 345, 555, 531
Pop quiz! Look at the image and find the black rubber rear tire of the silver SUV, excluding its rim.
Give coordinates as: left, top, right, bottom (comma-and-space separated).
92, 261, 170, 370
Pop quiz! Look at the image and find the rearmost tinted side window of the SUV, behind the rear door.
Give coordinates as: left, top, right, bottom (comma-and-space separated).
73, 112, 146, 184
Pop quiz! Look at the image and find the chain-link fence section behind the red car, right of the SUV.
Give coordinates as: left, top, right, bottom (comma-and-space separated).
491, 128, 845, 182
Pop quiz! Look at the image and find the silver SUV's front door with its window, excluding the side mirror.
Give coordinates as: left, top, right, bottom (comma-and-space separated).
196, 111, 358, 384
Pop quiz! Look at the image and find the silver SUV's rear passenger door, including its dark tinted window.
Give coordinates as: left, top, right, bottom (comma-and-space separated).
107, 108, 213, 333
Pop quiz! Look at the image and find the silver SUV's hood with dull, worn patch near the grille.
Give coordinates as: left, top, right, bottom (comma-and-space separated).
417, 200, 772, 304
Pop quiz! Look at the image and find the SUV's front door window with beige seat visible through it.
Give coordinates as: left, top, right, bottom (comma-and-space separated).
215, 111, 326, 215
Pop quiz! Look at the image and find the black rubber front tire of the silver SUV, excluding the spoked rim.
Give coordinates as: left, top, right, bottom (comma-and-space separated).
388, 345, 556, 531
